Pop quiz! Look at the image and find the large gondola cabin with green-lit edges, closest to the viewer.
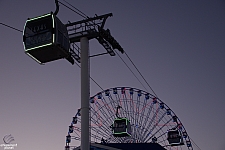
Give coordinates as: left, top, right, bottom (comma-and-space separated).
23, 13, 70, 64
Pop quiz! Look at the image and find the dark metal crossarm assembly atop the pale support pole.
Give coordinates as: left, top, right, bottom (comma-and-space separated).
65, 13, 124, 64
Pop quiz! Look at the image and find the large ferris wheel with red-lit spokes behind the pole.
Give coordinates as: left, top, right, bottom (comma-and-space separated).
66, 87, 193, 150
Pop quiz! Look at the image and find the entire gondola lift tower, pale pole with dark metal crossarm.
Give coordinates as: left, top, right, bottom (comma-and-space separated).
65, 13, 124, 150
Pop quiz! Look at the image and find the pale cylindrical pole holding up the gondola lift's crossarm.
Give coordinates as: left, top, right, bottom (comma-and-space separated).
80, 37, 90, 150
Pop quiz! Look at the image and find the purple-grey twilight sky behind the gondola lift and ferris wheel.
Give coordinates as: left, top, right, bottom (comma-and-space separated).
0, 0, 225, 150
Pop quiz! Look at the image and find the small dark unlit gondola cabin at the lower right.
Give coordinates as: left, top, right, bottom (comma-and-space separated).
167, 130, 184, 146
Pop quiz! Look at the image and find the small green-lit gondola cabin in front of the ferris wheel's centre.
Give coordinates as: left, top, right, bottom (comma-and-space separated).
113, 118, 131, 137
